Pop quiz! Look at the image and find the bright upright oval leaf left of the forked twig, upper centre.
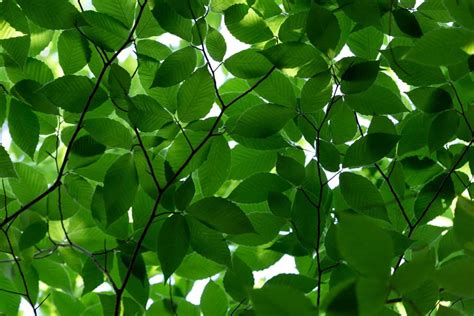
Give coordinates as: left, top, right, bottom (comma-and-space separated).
178, 66, 216, 122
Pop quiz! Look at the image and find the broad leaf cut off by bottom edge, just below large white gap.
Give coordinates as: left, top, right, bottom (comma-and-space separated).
251, 284, 317, 316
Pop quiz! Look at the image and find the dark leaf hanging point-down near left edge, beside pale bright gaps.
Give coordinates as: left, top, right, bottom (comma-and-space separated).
8, 99, 40, 158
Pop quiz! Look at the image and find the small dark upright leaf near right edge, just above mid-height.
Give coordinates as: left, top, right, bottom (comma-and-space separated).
428, 110, 460, 152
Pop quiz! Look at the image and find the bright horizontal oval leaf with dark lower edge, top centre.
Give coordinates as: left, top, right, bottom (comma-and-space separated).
224, 49, 272, 79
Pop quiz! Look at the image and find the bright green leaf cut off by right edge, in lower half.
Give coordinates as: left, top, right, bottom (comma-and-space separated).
453, 197, 474, 254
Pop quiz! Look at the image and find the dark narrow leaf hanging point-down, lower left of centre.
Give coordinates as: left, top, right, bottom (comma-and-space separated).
158, 214, 190, 283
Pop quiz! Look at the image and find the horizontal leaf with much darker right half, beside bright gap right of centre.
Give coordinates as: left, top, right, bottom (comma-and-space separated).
343, 133, 400, 168
